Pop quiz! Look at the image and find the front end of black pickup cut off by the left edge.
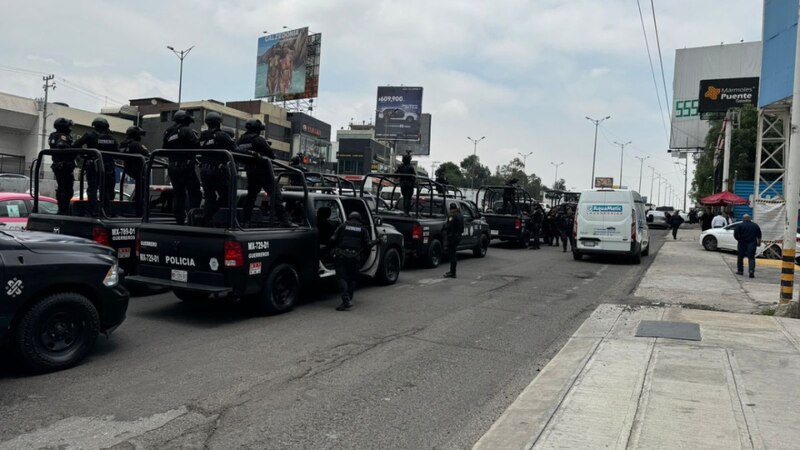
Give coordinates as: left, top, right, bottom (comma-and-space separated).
0, 231, 128, 372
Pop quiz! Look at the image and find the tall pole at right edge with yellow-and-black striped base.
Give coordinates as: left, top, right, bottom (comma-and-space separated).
780, 5, 800, 317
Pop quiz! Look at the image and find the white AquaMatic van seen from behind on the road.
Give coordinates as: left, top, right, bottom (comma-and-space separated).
572, 189, 650, 264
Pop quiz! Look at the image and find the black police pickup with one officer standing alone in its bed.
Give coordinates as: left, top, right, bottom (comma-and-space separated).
361, 173, 490, 268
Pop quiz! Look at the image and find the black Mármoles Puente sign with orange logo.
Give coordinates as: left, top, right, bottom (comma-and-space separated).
697, 77, 758, 114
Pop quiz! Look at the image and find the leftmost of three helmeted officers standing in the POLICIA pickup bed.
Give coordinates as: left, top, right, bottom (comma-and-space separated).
162, 110, 201, 225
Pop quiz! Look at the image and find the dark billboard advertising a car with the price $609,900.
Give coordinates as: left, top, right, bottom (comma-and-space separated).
375, 86, 422, 141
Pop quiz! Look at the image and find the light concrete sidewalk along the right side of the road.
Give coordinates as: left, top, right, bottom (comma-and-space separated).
474, 230, 800, 449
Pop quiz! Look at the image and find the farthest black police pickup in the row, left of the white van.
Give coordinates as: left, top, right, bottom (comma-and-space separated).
475, 186, 535, 247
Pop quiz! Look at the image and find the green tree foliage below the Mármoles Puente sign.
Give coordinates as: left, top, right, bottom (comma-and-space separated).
689, 106, 758, 201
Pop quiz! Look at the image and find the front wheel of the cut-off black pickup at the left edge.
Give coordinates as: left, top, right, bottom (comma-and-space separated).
14, 292, 100, 372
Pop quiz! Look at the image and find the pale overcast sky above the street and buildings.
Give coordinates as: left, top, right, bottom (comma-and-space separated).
0, 0, 762, 204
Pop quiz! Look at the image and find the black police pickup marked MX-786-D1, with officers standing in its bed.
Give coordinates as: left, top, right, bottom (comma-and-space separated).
27, 149, 159, 274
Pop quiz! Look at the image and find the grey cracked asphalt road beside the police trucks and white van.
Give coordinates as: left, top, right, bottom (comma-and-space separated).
0, 231, 664, 449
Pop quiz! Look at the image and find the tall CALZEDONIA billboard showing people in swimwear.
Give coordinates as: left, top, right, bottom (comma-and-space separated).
255, 27, 308, 98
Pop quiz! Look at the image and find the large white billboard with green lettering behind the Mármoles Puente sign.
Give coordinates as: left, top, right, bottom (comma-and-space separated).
669, 42, 761, 149
